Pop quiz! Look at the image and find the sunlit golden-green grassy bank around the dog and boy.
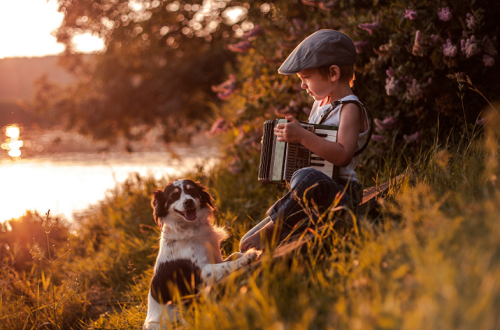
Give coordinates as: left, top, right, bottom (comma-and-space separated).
0, 107, 500, 330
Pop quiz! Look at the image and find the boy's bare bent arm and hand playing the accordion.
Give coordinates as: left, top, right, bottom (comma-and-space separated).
274, 103, 362, 167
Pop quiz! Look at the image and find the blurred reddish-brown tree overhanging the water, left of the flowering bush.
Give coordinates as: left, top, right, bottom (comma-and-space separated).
35, 0, 254, 141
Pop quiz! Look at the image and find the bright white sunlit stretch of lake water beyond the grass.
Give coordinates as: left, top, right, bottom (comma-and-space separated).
0, 147, 217, 221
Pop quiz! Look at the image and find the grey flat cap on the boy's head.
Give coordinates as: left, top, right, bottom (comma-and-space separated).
278, 30, 356, 74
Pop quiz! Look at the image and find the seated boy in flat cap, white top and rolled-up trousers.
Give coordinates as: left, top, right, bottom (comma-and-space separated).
240, 30, 369, 251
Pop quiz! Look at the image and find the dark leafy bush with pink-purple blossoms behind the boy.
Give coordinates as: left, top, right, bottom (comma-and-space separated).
211, 0, 500, 183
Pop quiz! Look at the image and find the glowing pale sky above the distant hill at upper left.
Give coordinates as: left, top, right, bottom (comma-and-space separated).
0, 0, 103, 58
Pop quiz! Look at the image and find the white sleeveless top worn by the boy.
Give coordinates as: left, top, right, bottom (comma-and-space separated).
309, 95, 370, 182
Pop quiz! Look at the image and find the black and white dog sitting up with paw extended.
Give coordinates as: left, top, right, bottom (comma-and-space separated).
144, 180, 256, 330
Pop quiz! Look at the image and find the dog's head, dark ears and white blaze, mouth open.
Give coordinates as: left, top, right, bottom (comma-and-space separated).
151, 180, 214, 228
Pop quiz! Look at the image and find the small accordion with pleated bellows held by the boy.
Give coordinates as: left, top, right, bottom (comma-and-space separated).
259, 119, 338, 184
